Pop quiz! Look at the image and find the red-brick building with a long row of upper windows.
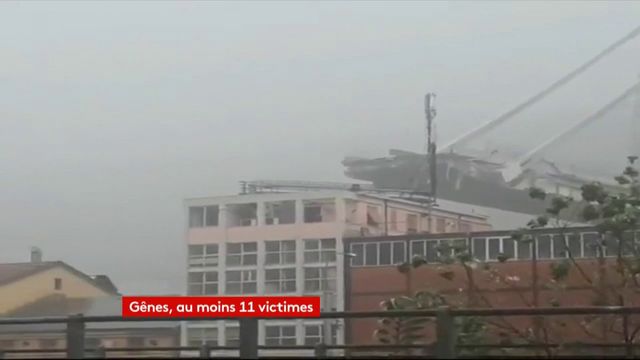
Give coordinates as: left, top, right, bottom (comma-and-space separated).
344, 227, 640, 345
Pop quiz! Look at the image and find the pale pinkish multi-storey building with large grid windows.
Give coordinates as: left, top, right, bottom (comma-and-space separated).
182, 191, 489, 352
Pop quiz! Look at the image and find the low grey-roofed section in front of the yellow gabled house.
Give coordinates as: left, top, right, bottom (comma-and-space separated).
0, 294, 180, 358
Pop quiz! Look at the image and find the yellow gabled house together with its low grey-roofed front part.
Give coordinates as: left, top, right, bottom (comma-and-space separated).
0, 248, 175, 358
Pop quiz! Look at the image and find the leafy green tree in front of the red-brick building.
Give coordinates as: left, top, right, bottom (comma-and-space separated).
376, 157, 640, 357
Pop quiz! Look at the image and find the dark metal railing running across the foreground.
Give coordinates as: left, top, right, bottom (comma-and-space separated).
0, 306, 640, 359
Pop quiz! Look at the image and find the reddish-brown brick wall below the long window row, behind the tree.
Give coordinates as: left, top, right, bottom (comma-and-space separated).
346, 229, 640, 344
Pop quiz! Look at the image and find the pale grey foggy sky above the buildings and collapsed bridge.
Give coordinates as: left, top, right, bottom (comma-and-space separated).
0, 1, 640, 294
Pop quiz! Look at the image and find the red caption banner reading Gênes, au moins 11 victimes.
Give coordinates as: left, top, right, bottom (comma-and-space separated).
122, 296, 320, 318
